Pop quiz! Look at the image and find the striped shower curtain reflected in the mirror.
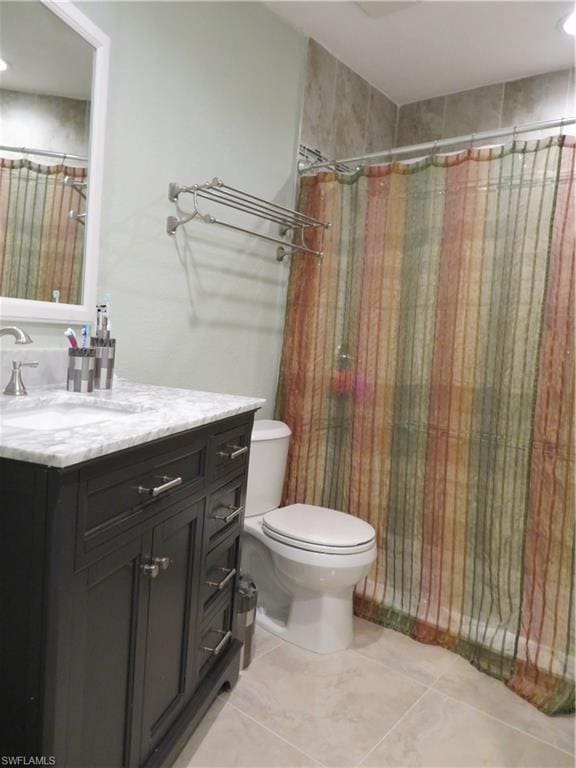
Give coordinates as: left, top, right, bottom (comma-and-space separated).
0, 158, 87, 304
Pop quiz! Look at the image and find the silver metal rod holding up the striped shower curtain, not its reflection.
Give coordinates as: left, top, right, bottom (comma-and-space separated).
298, 117, 576, 173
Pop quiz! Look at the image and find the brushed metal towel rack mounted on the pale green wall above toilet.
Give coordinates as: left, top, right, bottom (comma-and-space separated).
166, 178, 330, 261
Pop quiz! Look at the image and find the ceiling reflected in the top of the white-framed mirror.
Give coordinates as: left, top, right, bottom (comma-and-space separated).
0, 0, 93, 99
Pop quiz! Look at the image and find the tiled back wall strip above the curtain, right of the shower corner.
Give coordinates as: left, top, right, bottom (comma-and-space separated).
396, 69, 575, 147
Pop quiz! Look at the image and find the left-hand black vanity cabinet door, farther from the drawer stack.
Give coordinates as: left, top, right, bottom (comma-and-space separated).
63, 532, 152, 768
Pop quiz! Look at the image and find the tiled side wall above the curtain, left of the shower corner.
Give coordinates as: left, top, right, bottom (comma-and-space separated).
300, 40, 398, 158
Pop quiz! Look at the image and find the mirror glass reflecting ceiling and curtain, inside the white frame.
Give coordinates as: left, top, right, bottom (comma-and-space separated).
0, 0, 94, 304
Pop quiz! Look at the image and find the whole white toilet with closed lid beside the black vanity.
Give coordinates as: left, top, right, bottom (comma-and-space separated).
242, 420, 376, 653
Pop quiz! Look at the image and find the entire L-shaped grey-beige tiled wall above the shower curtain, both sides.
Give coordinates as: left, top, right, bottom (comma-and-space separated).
300, 40, 575, 158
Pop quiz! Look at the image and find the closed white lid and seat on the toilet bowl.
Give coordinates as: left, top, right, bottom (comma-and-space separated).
262, 504, 375, 551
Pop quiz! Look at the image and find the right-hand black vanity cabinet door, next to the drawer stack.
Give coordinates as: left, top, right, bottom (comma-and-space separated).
140, 499, 205, 762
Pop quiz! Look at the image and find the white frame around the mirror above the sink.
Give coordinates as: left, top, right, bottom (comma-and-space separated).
0, 0, 110, 324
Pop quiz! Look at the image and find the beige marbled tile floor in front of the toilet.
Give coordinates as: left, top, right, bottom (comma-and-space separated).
176, 619, 574, 768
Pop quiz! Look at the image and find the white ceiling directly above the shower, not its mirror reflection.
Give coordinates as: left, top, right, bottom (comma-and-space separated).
266, 0, 575, 104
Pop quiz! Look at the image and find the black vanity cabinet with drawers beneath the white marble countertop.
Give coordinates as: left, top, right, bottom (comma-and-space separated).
0, 413, 253, 768
